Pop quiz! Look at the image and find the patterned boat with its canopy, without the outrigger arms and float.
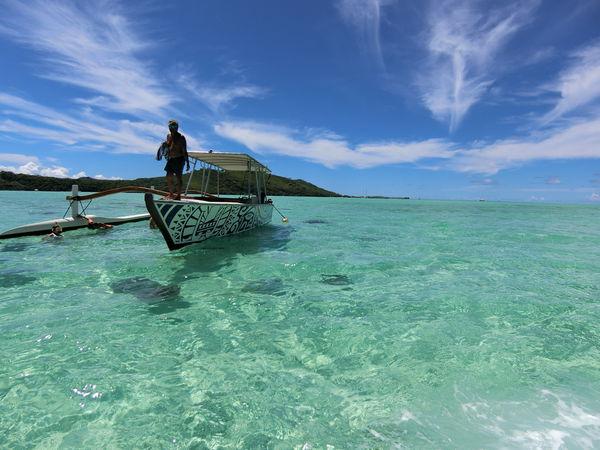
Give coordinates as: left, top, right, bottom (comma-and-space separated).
145, 152, 274, 250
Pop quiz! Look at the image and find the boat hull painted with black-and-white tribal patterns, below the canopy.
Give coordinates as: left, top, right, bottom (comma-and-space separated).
145, 194, 273, 250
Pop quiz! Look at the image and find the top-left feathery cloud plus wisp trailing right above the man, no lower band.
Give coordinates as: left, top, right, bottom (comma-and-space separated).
0, 0, 266, 132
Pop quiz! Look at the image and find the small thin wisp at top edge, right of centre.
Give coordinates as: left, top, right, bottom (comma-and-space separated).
337, 0, 393, 68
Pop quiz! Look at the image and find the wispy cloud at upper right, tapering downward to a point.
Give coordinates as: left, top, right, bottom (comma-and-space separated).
418, 0, 539, 131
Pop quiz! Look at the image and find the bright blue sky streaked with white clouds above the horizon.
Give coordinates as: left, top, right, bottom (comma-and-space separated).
0, 0, 600, 200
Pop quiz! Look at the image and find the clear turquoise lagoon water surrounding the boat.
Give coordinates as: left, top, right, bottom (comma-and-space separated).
0, 192, 600, 449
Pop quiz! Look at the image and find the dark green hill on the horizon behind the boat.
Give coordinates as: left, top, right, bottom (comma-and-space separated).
0, 171, 339, 197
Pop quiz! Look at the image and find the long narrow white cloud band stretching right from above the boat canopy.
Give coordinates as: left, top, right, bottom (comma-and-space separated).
215, 122, 453, 168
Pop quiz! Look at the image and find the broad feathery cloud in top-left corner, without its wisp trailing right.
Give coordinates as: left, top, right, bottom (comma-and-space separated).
0, 0, 174, 114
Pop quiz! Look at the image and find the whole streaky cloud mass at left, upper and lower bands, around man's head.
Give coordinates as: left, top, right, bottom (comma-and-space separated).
0, 0, 253, 160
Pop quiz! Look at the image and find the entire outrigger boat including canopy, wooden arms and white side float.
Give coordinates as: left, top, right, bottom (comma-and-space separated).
0, 152, 280, 250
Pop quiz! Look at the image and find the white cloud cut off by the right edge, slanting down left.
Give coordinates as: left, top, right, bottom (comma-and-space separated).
542, 41, 600, 123
